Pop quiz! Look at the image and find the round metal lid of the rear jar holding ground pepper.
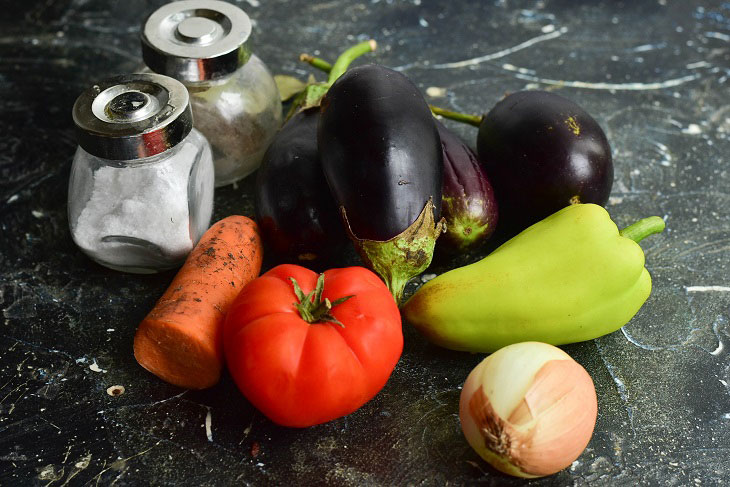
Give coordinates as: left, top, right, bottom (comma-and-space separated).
141, 0, 251, 82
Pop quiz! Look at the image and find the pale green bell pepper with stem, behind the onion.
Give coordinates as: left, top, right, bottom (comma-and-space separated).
401, 204, 664, 352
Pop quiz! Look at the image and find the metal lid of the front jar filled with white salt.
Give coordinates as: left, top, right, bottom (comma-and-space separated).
73, 74, 193, 160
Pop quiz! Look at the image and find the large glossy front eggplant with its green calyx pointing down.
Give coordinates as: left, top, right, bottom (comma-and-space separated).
317, 64, 444, 302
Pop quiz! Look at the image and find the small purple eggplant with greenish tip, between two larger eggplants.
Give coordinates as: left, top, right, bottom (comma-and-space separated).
436, 120, 497, 254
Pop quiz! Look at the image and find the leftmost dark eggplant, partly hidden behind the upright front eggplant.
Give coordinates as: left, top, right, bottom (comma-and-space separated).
255, 108, 348, 270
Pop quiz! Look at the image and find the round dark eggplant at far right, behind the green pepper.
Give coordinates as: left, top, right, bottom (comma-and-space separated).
477, 91, 613, 233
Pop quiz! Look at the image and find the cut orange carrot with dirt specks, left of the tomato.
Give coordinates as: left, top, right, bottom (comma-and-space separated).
134, 215, 263, 389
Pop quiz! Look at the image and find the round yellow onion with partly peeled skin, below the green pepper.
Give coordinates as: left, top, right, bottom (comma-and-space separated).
459, 342, 598, 478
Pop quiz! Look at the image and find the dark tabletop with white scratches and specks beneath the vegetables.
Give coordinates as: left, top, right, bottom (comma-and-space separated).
0, 0, 730, 486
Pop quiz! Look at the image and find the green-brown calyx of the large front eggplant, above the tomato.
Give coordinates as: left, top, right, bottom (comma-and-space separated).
340, 198, 446, 304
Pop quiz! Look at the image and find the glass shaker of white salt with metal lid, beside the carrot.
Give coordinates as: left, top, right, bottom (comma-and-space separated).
68, 74, 214, 273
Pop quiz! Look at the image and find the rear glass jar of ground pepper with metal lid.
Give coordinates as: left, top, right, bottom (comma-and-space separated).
141, 0, 281, 186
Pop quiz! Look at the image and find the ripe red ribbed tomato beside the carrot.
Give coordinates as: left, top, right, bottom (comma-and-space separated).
223, 264, 403, 427
